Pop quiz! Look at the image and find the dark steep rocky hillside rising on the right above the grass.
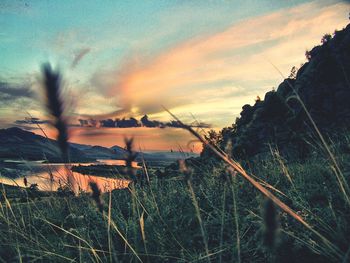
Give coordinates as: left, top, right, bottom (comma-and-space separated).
202, 25, 350, 158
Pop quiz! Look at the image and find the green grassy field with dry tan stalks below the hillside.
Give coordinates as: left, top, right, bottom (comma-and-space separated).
0, 134, 350, 262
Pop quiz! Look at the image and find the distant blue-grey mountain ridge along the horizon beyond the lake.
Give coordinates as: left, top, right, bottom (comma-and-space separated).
0, 127, 198, 162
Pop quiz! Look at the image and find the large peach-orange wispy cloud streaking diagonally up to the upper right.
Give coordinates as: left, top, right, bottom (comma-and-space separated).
94, 1, 349, 128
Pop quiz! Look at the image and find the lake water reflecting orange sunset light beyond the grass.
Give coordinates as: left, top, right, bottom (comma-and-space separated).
0, 160, 137, 192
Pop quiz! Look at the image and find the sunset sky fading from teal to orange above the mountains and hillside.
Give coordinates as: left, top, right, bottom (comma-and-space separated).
0, 0, 350, 151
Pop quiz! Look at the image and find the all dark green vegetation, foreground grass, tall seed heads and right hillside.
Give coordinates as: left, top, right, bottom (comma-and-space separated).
0, 16, 350, 262
